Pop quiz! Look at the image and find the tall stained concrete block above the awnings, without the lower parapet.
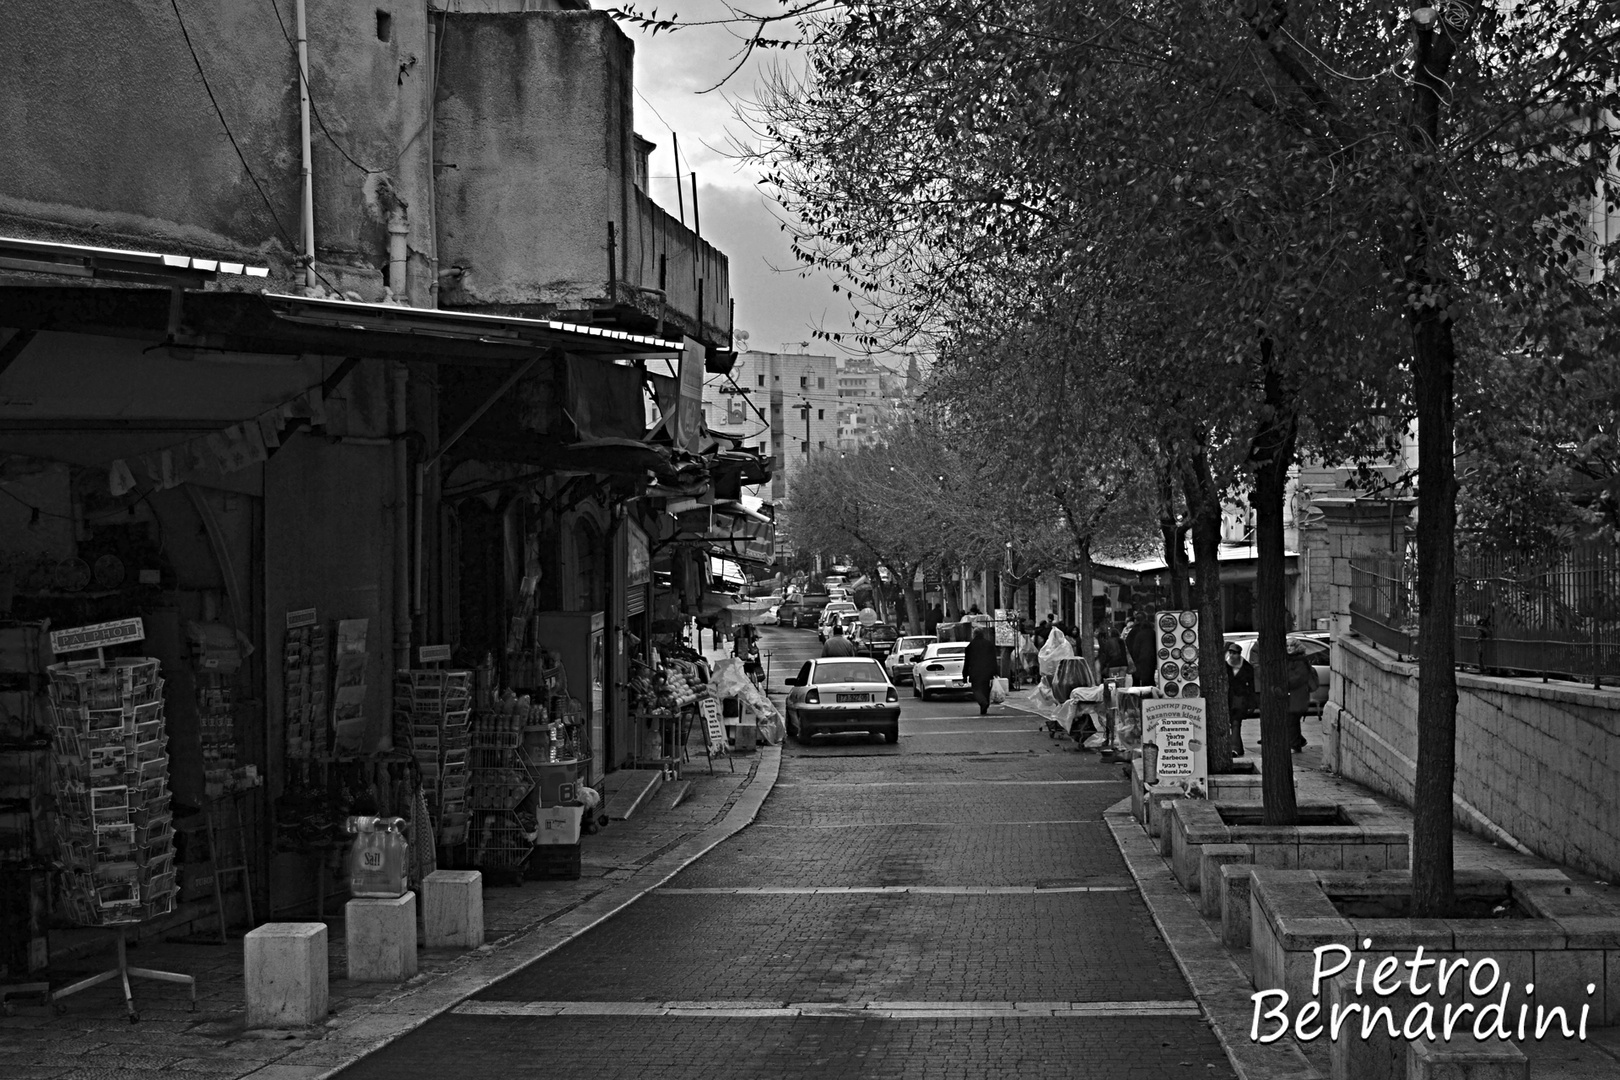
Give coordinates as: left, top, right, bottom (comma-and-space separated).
436, 11, 635, 308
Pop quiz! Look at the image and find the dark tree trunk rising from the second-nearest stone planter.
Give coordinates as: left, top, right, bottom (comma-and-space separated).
1251, 351, 1299, 826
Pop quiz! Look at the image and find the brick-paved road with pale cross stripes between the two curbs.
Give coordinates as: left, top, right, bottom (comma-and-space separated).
342, 630, 1233, 1080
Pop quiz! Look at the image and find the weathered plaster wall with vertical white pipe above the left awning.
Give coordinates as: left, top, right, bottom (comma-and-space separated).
0, 0, 431, 298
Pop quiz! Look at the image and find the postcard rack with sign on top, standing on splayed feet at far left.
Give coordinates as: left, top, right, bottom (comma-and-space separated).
49, 619, 198, 1023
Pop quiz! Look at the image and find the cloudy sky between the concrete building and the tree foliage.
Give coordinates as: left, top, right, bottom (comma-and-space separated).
625, 0, 868, 355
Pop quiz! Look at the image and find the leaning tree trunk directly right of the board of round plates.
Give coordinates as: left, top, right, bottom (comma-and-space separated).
1181, 443, 1239, 776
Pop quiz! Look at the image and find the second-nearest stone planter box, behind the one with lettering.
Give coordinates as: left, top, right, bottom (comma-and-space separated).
1165, 798, 1411, 893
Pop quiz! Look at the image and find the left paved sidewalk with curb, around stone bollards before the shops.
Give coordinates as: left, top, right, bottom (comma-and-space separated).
0, 732, 781, 1080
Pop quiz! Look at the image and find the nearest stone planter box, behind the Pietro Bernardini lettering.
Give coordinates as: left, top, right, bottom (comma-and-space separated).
1249, 866, 1620, 1038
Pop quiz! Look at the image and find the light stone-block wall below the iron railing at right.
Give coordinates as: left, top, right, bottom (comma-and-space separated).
1324, 636, 1620, 879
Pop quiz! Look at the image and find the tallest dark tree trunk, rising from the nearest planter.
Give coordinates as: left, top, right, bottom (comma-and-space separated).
1406, 19, 1456, 918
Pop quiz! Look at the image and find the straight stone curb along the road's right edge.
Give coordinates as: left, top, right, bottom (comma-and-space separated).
1103, 798, 1322, 1080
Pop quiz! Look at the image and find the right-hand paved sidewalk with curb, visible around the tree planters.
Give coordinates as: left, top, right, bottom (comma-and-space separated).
1105, 717, 1620, 1080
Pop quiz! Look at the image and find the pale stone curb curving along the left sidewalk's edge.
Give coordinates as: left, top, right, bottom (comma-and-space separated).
241, 746, 782, 1080
